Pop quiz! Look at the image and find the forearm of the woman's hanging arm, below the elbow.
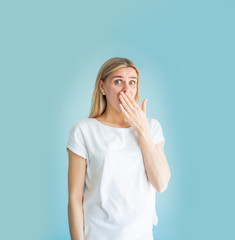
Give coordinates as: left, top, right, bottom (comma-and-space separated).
68, 200, 84, 240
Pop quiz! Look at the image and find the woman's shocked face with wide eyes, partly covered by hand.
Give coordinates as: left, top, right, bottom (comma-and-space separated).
100, 67, 138, 112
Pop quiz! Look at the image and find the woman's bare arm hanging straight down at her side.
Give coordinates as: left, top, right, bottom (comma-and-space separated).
68, 149, 86, 240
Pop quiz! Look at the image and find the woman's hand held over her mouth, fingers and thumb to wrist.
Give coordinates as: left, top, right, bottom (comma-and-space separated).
119, 92, 148, 133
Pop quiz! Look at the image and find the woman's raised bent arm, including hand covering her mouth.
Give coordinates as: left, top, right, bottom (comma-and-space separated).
117, 92, 171, 192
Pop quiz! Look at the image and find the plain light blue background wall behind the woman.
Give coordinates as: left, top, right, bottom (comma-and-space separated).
0, 0, 235, 240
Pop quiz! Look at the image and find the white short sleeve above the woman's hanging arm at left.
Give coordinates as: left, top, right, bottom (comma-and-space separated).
66, 122, 87, 159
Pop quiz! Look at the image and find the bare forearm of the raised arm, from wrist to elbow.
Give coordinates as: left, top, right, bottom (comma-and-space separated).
138, 128, 170, 192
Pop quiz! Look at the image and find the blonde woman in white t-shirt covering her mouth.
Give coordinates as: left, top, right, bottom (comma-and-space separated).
66, 57, 171, 240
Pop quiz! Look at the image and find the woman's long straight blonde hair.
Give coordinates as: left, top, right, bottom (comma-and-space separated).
89, 57, 140, 118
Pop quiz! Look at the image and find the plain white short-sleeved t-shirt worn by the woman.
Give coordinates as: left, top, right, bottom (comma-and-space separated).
66, 118, 165, 240
